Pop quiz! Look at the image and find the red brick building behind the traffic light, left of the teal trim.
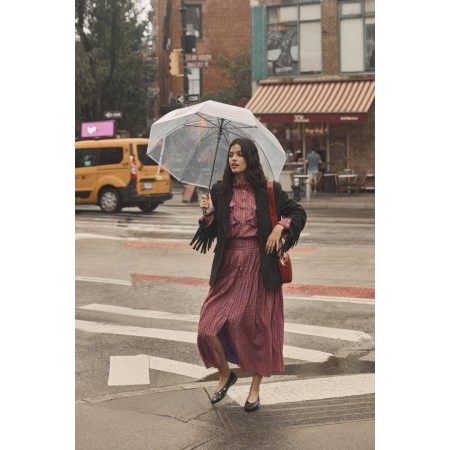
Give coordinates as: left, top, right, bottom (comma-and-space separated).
154, 0, 251, 116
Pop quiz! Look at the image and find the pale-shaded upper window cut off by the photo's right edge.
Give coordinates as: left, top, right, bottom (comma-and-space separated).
339, 0, 375, 72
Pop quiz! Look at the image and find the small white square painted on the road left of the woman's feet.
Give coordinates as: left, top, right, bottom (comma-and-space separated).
108, 355, 150, 386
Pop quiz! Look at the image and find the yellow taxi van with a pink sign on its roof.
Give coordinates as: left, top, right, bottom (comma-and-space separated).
75, 138, 172, 213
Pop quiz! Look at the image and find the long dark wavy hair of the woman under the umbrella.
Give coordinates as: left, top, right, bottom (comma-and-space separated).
222, 138, 266, 191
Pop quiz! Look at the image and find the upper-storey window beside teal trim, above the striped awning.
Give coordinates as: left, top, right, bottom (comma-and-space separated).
267, 1, 322, 76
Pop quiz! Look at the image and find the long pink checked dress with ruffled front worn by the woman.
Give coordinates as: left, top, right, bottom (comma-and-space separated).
197, 183, 290, 377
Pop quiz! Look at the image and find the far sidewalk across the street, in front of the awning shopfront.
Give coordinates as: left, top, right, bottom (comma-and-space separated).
164, 181, 375, 211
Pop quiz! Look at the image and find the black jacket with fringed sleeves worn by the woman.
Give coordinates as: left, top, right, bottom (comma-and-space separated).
191, 182, 306, 289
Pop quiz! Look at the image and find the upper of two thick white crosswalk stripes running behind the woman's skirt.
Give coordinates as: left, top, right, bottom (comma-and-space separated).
79, 303, 371, 342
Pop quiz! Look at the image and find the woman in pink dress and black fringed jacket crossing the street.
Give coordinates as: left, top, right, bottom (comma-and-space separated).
191, 138, 306, 411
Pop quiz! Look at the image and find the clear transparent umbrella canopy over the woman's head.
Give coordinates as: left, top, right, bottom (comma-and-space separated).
147, 100, 286, 189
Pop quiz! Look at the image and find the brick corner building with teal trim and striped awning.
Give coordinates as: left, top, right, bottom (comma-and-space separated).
246, 0, 375, 173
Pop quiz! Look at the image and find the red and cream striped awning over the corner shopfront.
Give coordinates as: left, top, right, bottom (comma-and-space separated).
245, 80, 375, 122
